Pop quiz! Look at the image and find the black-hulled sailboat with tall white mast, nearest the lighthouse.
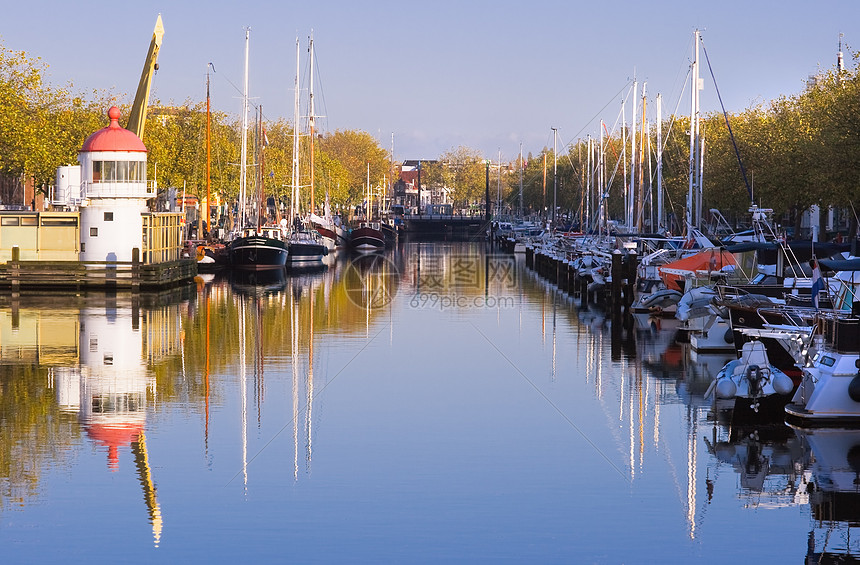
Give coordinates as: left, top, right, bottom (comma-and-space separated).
229, 29, 289, 270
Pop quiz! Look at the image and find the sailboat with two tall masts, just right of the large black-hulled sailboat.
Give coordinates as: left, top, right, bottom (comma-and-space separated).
287, 38, 328, 265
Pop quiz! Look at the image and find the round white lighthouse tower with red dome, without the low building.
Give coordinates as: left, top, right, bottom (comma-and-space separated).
78, 106, 155, 261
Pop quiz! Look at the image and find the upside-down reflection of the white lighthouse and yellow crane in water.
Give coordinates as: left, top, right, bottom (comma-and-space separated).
48, 297, 181, 546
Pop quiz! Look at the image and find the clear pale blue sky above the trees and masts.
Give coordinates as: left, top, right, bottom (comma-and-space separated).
0, 0, 860, 162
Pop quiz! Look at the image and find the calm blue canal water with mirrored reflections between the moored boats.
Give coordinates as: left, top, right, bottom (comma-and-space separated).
0, 244, 848, 563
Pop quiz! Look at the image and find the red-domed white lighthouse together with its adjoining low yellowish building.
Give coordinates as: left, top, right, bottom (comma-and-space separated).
0, 106, 183, 274
